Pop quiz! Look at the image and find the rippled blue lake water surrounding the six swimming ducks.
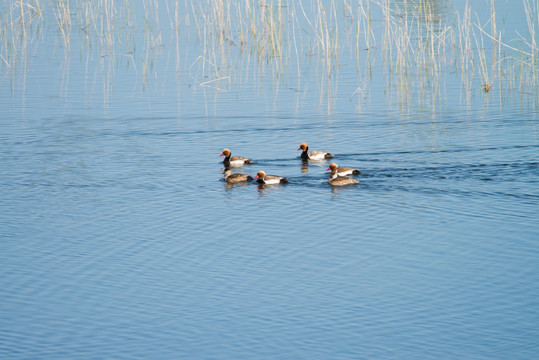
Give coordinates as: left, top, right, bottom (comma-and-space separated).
0, 1, 539, 359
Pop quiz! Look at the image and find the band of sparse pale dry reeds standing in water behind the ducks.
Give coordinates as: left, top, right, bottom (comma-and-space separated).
0, 0, 539, 106
